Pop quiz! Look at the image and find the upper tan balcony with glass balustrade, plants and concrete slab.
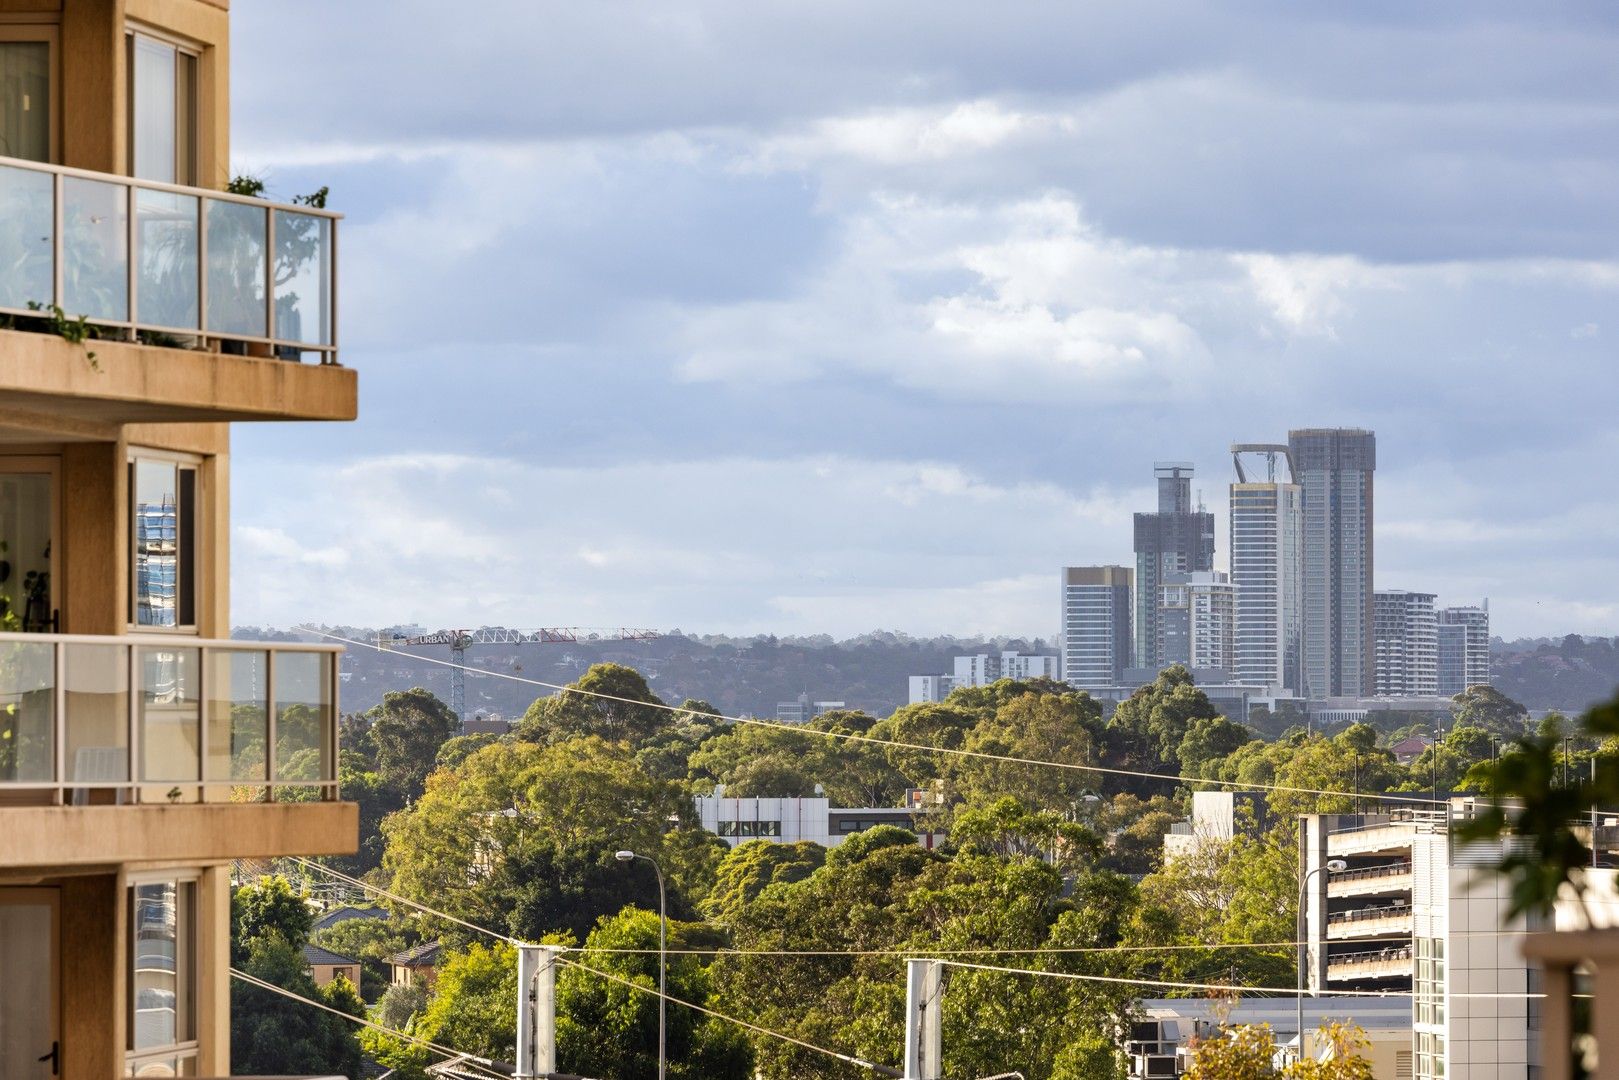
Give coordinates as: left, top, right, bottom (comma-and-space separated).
0, 157, 355, 423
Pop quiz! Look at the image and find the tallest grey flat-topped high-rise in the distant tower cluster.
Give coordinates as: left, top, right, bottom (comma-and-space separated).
1287, 427, 1378, 698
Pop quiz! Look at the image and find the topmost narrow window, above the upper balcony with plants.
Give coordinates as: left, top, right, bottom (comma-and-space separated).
130, 34, 198, 185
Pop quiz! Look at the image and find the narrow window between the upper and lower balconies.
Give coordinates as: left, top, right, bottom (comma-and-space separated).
130, 457, 198, 630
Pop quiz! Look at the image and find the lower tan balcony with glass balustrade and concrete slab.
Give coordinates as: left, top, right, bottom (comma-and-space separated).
0, 633, 356, 866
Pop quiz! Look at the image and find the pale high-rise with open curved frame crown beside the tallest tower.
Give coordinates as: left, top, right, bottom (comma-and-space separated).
1230, 444, 1303, 695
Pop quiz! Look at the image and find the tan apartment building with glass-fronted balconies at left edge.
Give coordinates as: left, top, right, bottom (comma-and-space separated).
0, 0, 358, 1080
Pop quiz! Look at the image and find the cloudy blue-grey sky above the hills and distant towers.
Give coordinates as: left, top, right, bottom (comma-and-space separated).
233, 0, 1619, 636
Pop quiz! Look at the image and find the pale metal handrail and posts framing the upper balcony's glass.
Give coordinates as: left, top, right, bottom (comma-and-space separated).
0, 157, 343, 363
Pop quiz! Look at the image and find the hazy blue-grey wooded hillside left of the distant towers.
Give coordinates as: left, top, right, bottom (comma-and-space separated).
235, 627, 1056, 717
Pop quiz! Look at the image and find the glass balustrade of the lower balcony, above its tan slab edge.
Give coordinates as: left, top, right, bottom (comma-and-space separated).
0, 633, 342, 806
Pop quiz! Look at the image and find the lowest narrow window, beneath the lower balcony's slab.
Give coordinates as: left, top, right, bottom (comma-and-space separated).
126, 878, 198, 1077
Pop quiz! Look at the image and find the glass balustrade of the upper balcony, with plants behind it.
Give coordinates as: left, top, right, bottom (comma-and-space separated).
0, 157, 340, 363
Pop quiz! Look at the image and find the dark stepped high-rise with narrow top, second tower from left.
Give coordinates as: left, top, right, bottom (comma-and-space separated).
1135, 461, 1214, 672
